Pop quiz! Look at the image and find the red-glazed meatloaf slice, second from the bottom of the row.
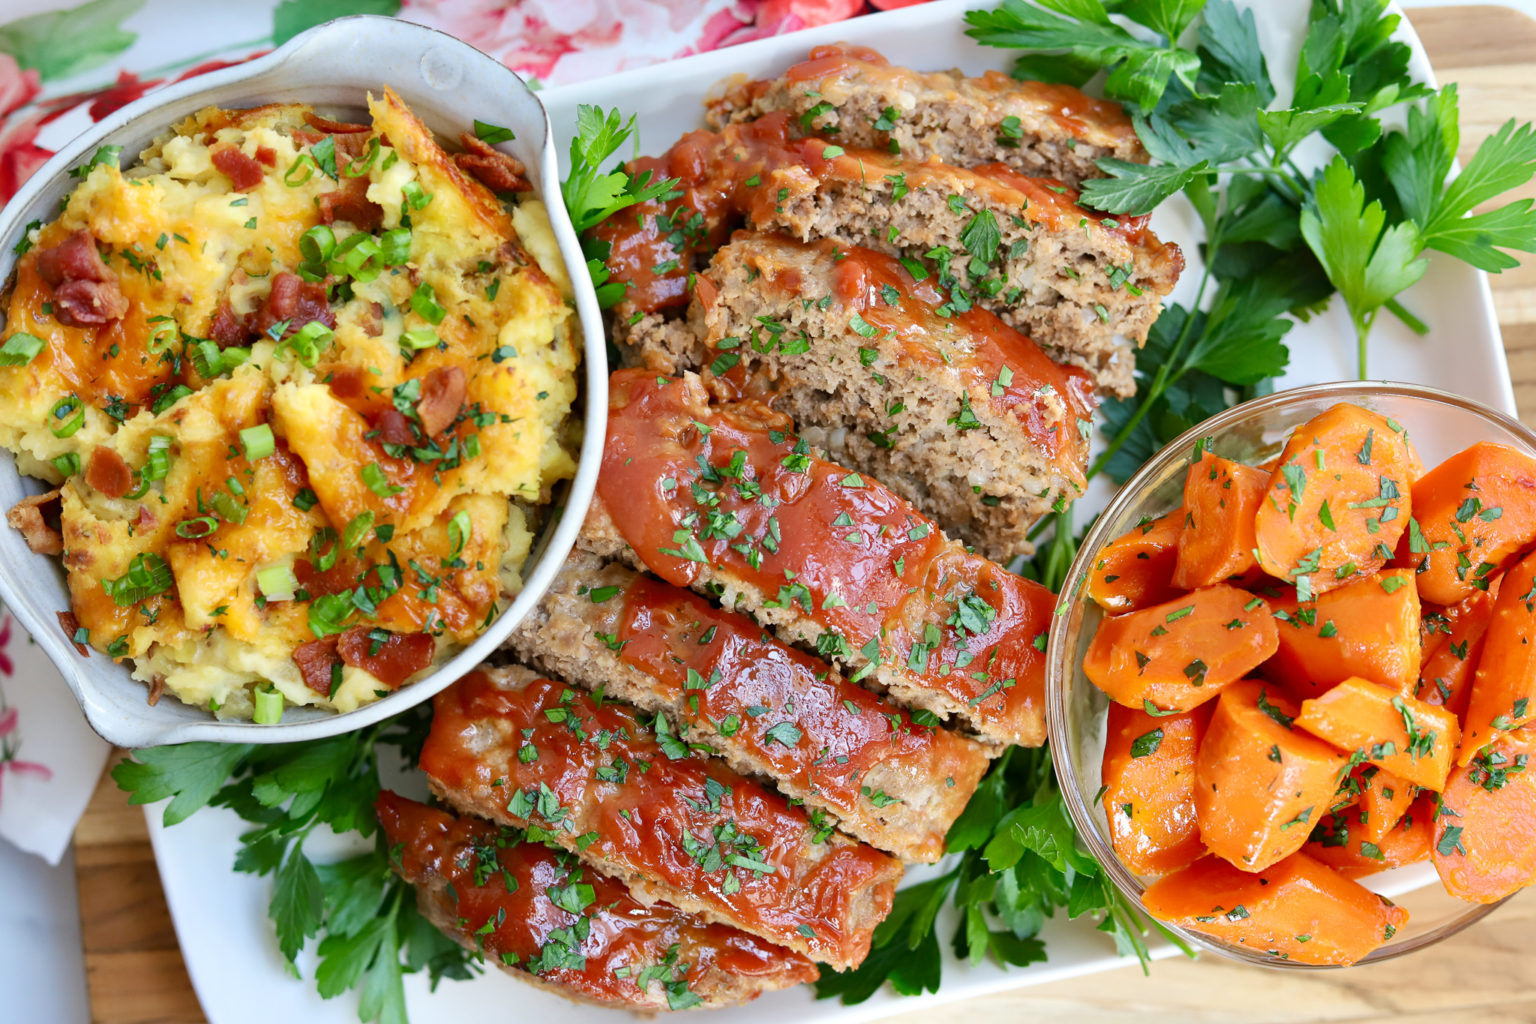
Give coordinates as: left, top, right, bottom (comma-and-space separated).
421, 668, 902, 970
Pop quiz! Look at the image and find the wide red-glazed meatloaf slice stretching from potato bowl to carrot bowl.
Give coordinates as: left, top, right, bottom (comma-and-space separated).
581, 370, 1055, 746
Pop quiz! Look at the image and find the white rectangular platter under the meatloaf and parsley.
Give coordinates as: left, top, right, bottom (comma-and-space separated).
147, 0, 1514, 1024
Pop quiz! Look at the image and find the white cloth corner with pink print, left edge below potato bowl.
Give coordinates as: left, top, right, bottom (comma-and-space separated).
0, 611, 111, 864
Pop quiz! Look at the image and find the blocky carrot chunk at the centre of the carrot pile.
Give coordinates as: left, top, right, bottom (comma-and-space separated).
1264, 570, 1419, 697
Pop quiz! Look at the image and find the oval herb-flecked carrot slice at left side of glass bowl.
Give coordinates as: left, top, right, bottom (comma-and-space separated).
1083, 583, 1275, 711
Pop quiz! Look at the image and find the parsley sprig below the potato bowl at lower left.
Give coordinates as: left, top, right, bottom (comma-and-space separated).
112, 705, 478, 1024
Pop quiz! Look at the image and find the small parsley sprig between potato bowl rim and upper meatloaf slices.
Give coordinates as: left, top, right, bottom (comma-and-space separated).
561, 103, 677, 309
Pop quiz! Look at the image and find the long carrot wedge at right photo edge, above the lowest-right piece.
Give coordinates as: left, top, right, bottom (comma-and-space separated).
1458, 554, 1536, 765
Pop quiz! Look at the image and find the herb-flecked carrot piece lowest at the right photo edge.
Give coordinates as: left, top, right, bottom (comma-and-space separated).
1430, 729, 1536, 903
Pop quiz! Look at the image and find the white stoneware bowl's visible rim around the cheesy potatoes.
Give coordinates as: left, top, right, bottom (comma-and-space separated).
0, 15, 608, 748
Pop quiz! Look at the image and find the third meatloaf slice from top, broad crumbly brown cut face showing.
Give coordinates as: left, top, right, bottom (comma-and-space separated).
639, 233, 1094, 562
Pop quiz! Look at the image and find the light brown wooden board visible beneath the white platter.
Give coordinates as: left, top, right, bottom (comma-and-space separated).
74, 6, 1536, 1024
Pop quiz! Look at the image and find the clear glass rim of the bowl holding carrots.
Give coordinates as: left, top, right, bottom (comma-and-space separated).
1046, 381, 1536, 970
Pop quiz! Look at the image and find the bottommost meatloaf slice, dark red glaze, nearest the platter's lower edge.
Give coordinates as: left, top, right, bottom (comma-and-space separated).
376, 791, 817, 1010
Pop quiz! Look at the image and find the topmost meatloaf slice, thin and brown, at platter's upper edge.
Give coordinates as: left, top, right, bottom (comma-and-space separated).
708, 43, 1147, 186
